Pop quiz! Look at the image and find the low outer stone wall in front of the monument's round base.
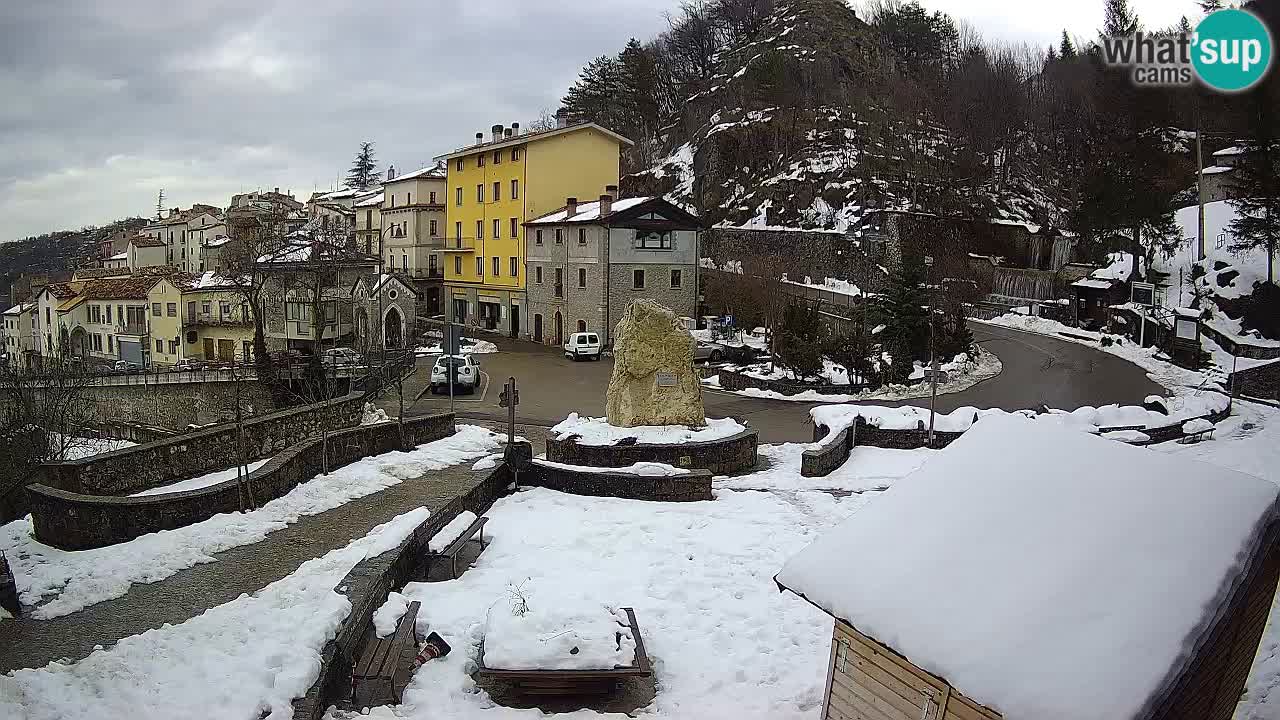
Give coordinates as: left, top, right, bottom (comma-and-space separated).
520, 461, 713, 502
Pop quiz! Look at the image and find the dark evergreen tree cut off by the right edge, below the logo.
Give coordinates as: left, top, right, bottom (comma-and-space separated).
1230, 94, 1280, 283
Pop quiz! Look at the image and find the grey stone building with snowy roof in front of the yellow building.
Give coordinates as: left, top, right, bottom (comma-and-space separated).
525, 193, 699, 345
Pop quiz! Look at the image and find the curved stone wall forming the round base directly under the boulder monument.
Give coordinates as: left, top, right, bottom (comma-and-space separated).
547, 429, 759, 475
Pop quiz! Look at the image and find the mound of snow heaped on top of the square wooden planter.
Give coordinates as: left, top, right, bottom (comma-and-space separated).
484, 599, 636, 670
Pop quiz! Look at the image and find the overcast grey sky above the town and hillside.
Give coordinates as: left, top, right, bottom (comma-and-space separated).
0, 0, 1196, 241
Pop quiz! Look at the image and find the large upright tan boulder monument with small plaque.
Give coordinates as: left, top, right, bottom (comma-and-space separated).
604, 300, 707, 428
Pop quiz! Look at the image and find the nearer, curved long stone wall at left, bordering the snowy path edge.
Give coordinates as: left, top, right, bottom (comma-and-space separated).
27, 414, 453, 550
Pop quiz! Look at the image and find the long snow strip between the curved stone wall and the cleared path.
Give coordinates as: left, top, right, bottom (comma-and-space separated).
0, 425, 500, 619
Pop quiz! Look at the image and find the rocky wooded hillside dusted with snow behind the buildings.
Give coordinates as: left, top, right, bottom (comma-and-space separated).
562, 0, 1280, 272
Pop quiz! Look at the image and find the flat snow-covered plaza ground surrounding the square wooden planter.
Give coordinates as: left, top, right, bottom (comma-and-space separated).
386, 488, 867, 720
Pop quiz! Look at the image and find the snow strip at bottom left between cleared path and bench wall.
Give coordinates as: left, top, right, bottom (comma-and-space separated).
0, 507, 429, 719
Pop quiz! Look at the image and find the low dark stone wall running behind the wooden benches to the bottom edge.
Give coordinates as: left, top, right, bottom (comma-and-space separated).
293, 464, 512, 720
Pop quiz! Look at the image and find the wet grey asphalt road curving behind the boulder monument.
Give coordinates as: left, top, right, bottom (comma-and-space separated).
380, 323, 1164, 445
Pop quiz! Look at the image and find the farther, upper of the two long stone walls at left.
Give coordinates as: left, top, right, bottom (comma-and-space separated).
0, 393, 365, 521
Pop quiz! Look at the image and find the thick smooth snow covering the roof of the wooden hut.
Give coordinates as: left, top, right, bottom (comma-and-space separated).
777, 415, 1280, 720
